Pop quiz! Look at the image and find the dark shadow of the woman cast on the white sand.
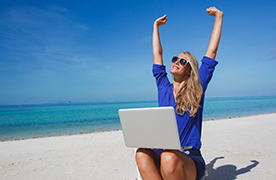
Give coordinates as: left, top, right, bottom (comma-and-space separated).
205, 157, 259, 180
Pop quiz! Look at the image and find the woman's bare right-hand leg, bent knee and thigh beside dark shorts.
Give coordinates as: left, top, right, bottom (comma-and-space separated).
160, 150, 196, 180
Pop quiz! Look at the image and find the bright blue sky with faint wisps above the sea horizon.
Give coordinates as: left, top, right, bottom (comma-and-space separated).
0, 0, 276, 105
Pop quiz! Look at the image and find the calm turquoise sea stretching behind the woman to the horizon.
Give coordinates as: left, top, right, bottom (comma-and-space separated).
0, 96, 276, 141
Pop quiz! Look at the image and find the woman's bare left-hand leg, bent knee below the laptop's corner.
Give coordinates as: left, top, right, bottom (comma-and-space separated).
135, 148, 162, 180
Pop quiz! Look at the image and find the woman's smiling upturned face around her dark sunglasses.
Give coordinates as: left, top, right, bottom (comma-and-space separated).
170, 53, 190, 80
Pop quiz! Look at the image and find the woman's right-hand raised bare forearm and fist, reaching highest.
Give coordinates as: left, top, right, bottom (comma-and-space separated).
205, 7, 223, 59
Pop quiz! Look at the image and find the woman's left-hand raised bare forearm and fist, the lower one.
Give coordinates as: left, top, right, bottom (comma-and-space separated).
152, 15, 168, 65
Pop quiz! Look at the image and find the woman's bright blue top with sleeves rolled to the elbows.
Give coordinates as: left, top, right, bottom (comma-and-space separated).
152, 56, 218, 149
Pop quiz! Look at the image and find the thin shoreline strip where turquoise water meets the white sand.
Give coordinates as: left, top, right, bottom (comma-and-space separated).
0, 112, 276, 143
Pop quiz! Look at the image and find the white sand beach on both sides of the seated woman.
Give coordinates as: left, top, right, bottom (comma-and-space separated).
0, 113, 276, 180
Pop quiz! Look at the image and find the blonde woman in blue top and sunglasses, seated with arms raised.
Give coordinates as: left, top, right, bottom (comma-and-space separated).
136, 7, 223, 180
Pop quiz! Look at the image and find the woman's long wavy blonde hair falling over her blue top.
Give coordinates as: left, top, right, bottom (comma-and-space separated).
176, 51, 203, 117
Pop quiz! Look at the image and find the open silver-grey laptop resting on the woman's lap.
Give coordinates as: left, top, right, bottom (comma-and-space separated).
118, 107, 192, 149
